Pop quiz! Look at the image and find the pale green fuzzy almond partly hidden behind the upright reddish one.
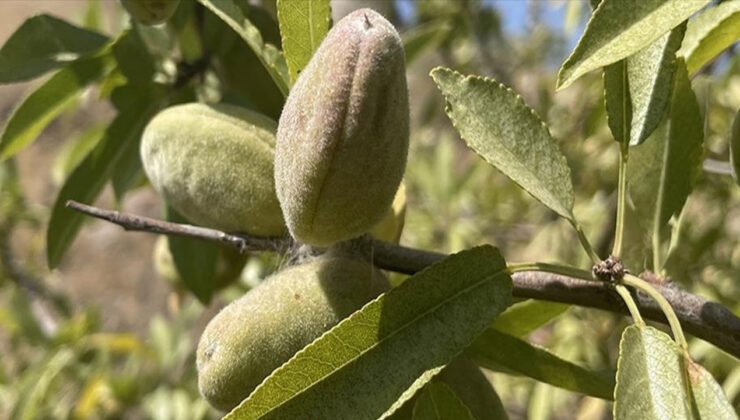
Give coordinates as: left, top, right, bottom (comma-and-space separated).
141, 103, 285, 236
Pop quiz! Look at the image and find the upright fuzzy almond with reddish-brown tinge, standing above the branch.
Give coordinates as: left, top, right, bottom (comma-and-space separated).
275, 9, 409, 246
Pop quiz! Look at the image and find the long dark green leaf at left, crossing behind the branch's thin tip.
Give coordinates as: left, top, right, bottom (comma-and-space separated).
46, 91, 161, 268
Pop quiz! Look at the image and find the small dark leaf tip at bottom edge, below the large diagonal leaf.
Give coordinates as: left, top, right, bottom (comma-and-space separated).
412, 382, 475, 420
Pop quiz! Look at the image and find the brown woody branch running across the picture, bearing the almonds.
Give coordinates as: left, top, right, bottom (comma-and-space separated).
67, 201, 740, 358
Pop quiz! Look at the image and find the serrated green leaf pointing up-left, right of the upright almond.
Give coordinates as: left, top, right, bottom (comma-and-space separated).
431, 67, 573, 221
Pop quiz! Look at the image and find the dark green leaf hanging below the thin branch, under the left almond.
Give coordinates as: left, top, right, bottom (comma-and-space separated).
167, 206, 219, 305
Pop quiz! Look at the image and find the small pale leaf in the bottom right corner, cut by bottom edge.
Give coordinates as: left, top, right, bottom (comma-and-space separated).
684, 358, 738, 420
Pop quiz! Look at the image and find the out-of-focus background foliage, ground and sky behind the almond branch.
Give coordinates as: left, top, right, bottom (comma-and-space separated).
0, 0, 740, 419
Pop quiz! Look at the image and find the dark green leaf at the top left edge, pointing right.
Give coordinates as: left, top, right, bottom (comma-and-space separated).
0, 15, 108, 84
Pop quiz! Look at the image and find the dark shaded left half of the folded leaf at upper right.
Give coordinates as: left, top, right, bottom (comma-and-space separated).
604, 60, 632, 143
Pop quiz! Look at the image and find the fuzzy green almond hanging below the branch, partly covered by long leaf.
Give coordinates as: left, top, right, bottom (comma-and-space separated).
196, 255, 390, 410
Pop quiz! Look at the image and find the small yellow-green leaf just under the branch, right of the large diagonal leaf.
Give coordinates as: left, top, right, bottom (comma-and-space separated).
491, 299, 570, 337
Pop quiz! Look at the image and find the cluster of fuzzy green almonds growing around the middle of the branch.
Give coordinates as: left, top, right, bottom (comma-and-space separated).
141, 9, 500, 418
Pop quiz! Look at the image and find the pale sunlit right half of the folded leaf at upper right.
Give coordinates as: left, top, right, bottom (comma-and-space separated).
627, 24, 686, 146
